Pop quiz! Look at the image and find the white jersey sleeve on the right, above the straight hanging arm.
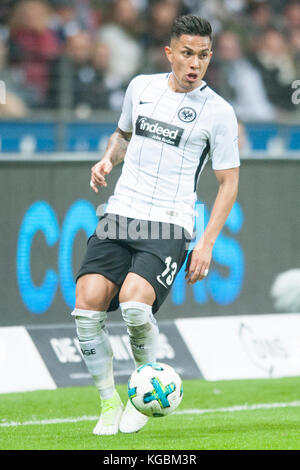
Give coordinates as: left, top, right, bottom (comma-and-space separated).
210, 105, 240, 170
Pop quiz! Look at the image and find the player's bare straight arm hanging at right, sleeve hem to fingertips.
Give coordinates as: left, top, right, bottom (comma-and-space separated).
186, 167, 239, 284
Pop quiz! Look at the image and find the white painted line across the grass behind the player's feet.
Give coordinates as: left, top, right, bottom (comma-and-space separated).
0, 401, 300, 428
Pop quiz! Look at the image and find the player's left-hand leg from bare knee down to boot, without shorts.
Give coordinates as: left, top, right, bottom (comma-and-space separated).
72, 274, 123, 435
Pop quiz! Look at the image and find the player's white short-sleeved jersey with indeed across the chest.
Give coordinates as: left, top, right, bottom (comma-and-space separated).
106, 74, 240, 234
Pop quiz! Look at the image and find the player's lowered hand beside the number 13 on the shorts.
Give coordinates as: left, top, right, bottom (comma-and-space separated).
185, 246, 212, 284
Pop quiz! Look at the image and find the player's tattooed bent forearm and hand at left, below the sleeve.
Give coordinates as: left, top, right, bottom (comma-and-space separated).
90, 127, 131, 193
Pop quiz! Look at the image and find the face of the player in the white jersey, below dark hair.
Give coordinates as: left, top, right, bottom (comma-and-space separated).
165, 34, 212, 93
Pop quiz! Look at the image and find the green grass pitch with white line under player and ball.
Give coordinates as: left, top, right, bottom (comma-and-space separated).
0, 377, 300, 450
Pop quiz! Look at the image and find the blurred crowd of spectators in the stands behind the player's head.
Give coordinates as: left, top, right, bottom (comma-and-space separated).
0, 0, 300, 121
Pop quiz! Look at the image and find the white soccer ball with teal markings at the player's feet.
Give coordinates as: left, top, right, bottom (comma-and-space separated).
128, 362, 183, 418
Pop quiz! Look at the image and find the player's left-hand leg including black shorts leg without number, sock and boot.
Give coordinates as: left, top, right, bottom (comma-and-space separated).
73, 226, 131, 434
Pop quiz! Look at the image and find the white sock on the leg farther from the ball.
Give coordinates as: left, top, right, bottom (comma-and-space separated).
72, 308, 115, 400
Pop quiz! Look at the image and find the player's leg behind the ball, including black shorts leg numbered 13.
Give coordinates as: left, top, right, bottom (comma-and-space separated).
119, 231, 190, 432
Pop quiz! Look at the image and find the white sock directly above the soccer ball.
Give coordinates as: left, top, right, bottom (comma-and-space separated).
120, 302, 159, 367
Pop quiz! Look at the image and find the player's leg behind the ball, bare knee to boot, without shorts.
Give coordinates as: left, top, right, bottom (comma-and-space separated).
119, 272, 159, 433
